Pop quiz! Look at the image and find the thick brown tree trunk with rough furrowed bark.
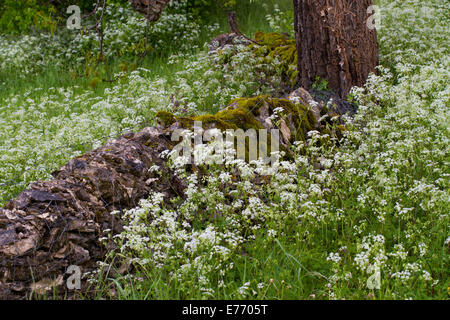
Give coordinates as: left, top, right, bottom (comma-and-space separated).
293, 0, 379, 97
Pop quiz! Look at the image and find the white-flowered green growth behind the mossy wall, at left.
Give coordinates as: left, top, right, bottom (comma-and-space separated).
0, 2, 296, 203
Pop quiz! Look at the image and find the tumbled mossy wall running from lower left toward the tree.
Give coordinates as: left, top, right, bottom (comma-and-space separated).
0, 93, 330, 299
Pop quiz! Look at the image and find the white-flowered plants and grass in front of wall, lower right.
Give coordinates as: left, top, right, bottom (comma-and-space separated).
87, 0, 450, 300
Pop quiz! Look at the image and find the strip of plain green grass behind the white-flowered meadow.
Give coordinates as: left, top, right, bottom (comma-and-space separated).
0, 0, 292, 101
